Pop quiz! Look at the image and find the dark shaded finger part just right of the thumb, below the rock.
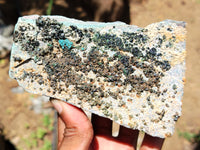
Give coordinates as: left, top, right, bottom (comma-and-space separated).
92, 114, 112, 136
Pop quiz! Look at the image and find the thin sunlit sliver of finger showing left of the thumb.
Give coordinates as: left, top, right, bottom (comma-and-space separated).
58, 115, 65, 147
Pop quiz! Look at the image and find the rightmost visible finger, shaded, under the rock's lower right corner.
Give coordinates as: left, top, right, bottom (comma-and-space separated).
140, 134, 164, 150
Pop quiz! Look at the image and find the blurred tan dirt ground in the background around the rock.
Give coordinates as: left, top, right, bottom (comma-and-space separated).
0, 0, 200, 150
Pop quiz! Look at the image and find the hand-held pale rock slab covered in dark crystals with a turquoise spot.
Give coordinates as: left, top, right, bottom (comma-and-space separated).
9, 15, 186, 138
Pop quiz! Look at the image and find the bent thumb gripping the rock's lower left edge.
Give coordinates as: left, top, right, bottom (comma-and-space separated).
51, 99, 93, 150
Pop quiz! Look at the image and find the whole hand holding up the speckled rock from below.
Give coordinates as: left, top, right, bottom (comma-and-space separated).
51, 99, 164, 150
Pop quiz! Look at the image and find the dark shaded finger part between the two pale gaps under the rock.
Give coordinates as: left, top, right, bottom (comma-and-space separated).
118, 126, 139, 149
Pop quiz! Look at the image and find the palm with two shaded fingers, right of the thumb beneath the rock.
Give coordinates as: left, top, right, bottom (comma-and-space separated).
90, 115, 138, 150
